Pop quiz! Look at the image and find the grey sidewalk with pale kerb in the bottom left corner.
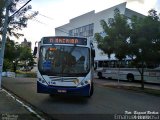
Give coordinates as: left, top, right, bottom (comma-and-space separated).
0, 89, 40, 120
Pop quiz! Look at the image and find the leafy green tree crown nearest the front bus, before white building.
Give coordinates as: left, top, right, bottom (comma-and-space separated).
95, 14, 130, 60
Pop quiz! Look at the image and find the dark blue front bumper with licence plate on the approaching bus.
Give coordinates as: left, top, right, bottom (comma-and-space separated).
37, 81, 91, 96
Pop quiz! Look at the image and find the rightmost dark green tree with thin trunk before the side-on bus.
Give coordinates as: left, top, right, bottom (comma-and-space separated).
130, 10, 160, 89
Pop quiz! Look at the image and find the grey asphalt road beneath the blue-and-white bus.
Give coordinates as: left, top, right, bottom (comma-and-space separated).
2, 78, 160, 120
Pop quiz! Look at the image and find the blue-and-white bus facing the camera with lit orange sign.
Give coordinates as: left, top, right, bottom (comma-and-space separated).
36, 36, 95, 97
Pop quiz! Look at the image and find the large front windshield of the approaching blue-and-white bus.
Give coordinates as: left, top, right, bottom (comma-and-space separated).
38, 45, 90, 76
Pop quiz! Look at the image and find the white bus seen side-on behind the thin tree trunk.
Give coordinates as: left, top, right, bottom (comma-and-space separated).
94, 59, 160, 84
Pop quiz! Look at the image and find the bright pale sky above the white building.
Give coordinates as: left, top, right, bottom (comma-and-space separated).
17, 0, 160, 48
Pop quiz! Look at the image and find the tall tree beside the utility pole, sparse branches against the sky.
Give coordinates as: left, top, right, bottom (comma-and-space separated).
0, 0, 38, 71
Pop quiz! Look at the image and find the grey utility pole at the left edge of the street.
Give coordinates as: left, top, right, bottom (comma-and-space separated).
0, 0, 11, 90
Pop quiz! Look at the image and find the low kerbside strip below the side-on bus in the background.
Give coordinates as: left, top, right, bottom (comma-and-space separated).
94, 79, 160, 90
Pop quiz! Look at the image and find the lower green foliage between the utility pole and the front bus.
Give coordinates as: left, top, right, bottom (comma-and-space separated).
3, 38, 35, 71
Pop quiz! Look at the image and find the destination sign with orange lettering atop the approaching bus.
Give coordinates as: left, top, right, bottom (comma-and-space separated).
43, 37, 87, 45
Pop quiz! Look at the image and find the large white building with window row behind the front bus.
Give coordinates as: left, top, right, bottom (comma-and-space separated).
55, 2, 144, 60
